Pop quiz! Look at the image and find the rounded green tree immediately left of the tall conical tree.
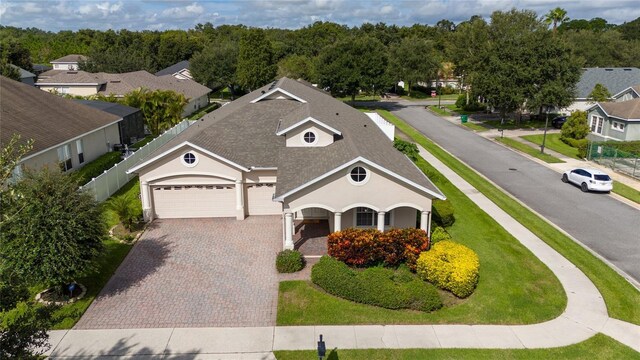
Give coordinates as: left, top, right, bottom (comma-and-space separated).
189, 42, 238, 94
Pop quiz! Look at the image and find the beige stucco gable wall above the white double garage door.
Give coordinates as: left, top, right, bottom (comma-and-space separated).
139, 146, 242, 185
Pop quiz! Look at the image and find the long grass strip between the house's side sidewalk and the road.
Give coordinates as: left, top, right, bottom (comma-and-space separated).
378, 110, 640, 325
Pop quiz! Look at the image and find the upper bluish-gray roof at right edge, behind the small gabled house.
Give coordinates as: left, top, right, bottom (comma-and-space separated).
576, 67, 640, 99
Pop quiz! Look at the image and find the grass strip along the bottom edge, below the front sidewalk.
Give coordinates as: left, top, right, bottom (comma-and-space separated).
274, 334, 638, 360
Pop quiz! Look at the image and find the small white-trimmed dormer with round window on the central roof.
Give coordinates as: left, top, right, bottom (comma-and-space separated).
276, 116, 342, 147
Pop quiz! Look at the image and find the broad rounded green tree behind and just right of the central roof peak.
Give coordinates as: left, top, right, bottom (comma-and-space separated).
316, 36, 390, 101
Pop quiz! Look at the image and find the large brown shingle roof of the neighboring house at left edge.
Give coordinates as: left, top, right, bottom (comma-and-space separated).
0, 77, 121, 155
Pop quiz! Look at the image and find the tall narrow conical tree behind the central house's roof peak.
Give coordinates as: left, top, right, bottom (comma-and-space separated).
236, 29, 277, 91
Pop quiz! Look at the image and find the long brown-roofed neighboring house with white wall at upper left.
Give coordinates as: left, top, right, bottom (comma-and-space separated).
36, 70, 211, 116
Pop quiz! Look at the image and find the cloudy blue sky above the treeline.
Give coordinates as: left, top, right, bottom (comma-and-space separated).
0, 0, 640, 31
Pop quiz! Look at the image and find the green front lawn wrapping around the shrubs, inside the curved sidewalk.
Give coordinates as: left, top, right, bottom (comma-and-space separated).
277, 154, 566, 325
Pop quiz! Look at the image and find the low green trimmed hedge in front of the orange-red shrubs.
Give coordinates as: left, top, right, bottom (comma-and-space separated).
311, 256, 442, 311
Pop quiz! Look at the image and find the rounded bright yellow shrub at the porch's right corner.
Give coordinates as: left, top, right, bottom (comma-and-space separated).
416, 240, 480, 298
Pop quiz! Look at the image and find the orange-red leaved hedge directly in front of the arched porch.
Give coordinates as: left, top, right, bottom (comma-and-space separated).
327, 228, 429, 269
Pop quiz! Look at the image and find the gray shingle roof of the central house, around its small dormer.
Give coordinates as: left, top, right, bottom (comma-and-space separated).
134, 78, 442, 200
